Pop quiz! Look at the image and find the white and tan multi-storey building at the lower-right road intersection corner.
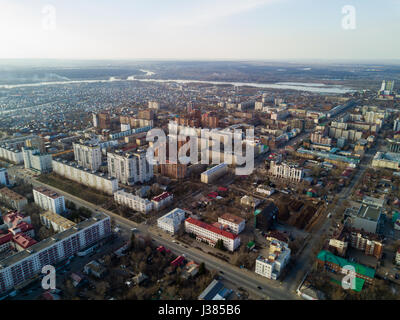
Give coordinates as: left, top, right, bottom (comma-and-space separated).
255, 240, 290, 280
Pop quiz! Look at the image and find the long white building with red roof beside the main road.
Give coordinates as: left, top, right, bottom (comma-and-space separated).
185, 218, 240, 251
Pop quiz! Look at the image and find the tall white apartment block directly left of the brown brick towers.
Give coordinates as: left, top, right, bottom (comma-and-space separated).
107, 152, 153, 185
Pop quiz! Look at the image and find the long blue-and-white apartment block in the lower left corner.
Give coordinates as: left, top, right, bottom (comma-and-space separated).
0, 213, 111, 294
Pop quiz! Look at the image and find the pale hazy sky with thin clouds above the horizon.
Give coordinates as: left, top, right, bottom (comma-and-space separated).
0, 0, 400, 61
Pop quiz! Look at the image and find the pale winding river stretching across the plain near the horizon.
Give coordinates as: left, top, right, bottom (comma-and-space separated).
0, 70, 356, 94
